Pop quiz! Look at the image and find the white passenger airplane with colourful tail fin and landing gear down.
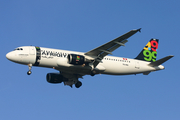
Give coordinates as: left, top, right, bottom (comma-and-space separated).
6, 28, 174, 88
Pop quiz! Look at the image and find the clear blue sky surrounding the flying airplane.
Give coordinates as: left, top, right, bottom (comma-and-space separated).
0, 0, 180, 120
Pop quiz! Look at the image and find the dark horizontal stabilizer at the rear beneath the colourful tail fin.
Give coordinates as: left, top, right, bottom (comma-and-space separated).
149, 55, 174, 67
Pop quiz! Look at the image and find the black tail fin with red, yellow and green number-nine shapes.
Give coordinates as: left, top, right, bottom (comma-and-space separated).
135, 39, 159, 62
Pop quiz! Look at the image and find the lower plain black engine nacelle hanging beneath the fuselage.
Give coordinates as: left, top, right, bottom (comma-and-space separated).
46, 73, 64, 84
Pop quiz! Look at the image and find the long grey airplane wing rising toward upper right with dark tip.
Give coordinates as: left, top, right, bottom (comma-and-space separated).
85, 28, 141, 67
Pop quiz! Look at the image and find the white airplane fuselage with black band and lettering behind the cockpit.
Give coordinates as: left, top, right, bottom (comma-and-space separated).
6, 46, 164, 75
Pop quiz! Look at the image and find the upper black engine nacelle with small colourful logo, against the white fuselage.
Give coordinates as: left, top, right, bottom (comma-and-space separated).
67, 54, 85, 65
